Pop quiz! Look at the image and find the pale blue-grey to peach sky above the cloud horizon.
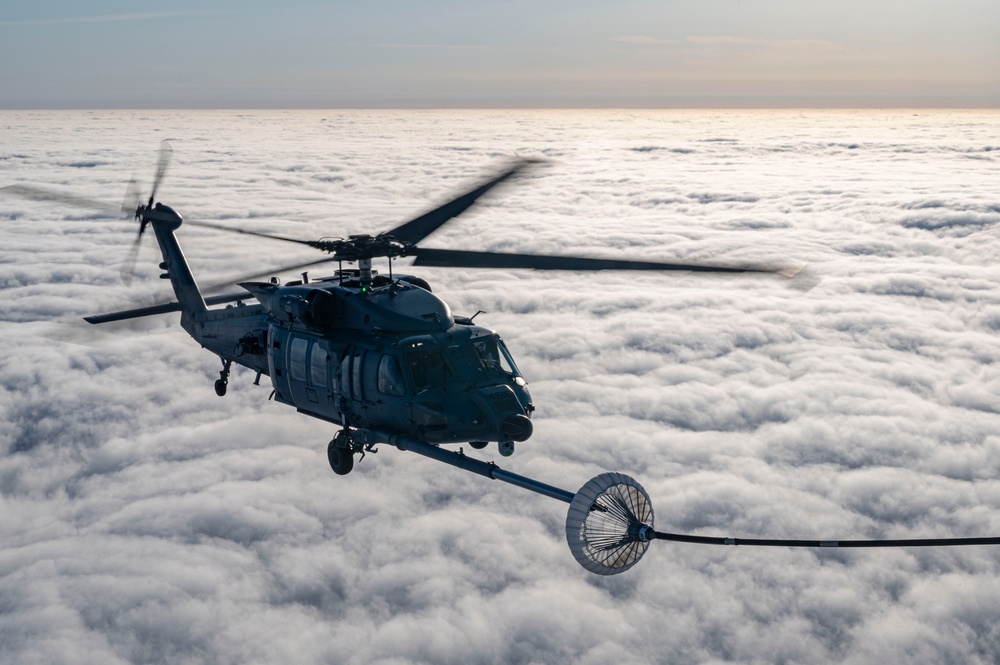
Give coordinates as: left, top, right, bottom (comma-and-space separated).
0, 0, 1000, 109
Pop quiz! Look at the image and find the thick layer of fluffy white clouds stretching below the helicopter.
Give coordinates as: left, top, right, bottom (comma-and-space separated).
0, 110, 1000, 665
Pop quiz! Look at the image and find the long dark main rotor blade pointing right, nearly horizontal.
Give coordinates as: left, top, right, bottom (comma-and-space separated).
408, 247, 784, 274
